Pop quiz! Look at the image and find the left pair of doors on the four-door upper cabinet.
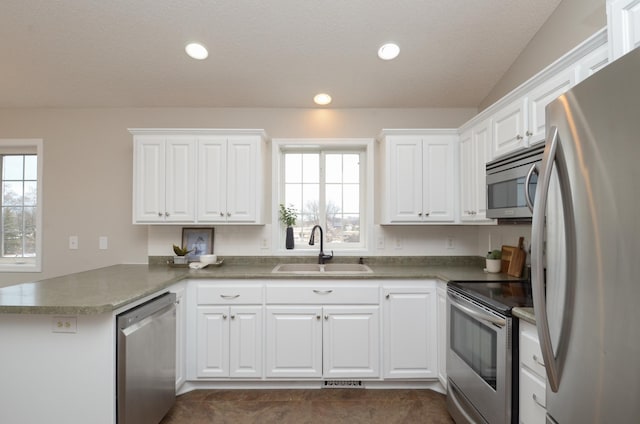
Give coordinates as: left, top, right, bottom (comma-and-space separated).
133, 134, 196, 223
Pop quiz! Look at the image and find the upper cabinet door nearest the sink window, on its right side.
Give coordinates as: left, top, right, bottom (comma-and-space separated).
386, 136, 423, 222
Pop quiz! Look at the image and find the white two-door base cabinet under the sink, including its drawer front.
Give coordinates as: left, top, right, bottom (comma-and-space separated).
266, 282, 380, 378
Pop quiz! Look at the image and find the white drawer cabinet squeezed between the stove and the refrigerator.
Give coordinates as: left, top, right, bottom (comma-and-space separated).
519, 320, 547, 424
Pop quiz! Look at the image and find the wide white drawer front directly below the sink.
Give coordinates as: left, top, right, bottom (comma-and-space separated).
267, 284, 380, 305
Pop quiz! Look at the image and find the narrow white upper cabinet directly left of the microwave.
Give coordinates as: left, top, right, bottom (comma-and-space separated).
460, 119, 493, 222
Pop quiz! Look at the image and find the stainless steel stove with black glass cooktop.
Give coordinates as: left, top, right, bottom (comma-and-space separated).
447, 281, 532, 424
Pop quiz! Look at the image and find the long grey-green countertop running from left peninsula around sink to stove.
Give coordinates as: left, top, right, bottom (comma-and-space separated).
0, 255, 524, 315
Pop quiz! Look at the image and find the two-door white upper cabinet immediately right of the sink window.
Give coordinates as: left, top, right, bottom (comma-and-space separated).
382, 130, 457, 224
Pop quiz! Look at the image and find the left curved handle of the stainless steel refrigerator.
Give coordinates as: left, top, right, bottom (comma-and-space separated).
531, 127, 560, 393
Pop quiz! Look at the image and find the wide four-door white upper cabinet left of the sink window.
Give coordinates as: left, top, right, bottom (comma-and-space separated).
130, 129, 265, 224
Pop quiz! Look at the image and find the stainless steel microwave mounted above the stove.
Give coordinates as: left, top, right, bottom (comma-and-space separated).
487, 143, 544, 221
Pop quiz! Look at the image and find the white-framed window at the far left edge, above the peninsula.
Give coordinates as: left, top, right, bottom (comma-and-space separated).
0, 140, 42, 272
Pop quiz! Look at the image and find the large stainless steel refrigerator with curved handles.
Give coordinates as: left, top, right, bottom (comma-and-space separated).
531, 49, 640, 424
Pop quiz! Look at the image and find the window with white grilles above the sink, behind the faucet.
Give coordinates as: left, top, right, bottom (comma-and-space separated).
280, 147, 366, 250
